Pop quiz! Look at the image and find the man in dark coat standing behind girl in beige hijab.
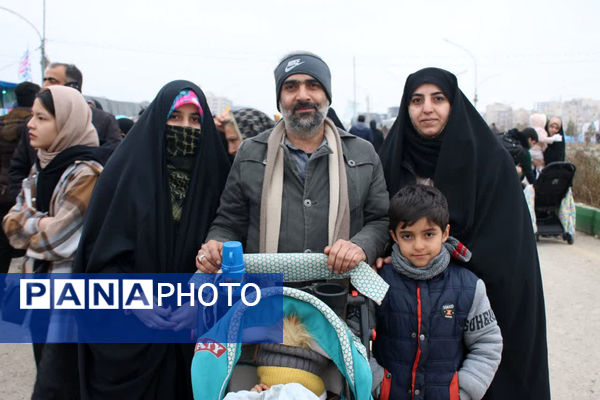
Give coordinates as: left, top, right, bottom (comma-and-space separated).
9, 63, 121, 197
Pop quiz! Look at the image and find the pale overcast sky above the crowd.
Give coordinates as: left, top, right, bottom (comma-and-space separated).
0, 0, 600, 119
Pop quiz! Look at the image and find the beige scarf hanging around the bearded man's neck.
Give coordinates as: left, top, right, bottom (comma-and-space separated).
259, 118, 350, 253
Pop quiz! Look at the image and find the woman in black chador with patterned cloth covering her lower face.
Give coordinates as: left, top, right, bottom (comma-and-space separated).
76, 81, 229, 399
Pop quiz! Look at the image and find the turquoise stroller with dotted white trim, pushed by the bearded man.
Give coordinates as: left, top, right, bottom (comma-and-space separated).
192, 254, 389, 400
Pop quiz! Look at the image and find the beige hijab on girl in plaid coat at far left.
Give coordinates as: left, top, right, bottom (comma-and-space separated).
37, 86, 99, 168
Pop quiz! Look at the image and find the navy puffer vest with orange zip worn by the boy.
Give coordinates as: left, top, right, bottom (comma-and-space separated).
373, 262, 477, 400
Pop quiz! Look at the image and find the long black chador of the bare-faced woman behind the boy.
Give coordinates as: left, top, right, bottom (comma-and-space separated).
380, 68, 550, 399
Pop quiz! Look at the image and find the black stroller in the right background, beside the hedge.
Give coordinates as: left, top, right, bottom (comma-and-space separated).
534, 162, 575, 244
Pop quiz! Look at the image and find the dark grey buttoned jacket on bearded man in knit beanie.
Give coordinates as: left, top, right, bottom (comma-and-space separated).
206, 125, 389, 263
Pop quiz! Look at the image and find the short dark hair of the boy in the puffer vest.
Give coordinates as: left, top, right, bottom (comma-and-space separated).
389, 185, 450, 231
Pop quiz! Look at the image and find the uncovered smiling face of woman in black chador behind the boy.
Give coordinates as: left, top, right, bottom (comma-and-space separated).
408, 83, 450, 137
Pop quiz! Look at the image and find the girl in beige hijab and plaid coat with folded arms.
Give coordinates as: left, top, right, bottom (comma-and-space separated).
2, 86, 105, 399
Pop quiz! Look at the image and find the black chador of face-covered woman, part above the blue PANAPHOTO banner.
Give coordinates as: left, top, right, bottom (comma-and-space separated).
76, 81, 229, 272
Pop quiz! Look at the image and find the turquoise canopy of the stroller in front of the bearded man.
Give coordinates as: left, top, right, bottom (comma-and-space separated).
191, 287, 372, 400
